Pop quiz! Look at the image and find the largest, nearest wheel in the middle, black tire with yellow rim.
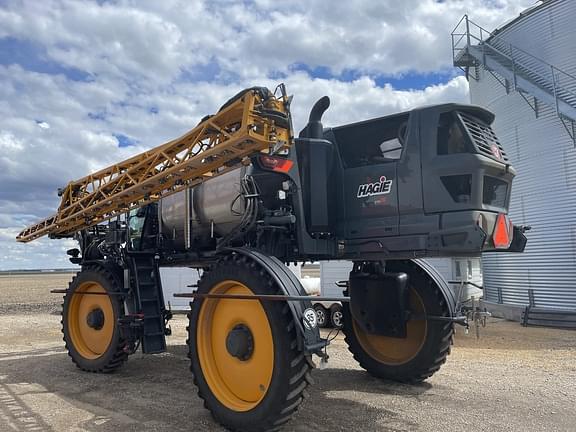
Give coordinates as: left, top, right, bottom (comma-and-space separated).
188, 254, 312, 431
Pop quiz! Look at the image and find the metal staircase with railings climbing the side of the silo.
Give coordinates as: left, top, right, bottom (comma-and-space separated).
452, 15, 576, 144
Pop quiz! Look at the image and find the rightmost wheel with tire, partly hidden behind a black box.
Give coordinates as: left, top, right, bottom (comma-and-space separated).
343, 267, 454, 384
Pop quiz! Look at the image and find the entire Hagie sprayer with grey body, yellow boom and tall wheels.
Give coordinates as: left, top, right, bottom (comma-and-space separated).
17, 85, 526, 431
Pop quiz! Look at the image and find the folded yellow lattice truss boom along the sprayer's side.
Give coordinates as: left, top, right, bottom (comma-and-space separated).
16, 85, 293, 242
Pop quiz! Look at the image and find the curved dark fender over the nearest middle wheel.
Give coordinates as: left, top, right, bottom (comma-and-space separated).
224, 248, 327, 356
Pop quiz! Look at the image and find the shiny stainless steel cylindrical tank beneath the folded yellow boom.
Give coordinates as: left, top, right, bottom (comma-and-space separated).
158, 167, 251, 251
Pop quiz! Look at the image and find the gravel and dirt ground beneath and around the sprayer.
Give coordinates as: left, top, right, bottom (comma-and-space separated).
0, 275, 576, 432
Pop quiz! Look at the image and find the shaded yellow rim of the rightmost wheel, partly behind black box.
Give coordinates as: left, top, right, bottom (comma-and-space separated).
352, 289, 428, 365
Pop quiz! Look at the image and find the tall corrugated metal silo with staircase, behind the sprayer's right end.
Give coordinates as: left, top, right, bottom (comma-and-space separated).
453, 0, 576, 318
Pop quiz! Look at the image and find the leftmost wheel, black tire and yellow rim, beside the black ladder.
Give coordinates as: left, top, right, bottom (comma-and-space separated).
61, 266, 128, 373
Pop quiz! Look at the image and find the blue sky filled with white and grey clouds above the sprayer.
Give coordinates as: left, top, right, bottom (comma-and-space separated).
0, 0, 534, 270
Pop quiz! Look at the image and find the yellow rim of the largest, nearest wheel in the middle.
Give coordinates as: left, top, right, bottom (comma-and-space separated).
196, 280, 274, 412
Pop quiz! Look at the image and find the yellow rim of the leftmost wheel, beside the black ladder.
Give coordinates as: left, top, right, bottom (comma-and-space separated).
67, 281, 114, 360
